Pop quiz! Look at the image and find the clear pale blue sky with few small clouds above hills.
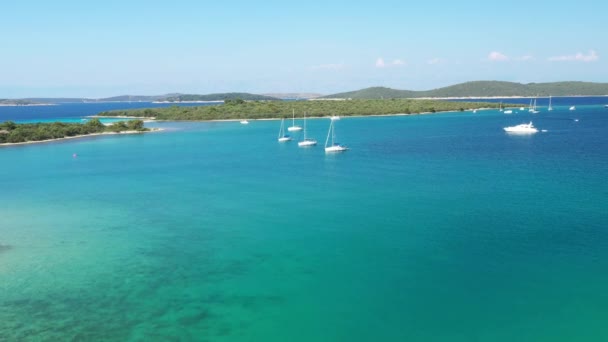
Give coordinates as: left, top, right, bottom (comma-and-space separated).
0, 0, 608, 98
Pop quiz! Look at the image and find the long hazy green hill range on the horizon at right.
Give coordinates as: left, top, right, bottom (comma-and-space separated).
324, 81, 608, 99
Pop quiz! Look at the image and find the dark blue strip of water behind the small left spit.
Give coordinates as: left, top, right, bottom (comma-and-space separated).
0, 102, 217, 122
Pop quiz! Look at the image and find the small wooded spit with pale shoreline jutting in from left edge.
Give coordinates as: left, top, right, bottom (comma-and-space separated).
0, 118, 150, 144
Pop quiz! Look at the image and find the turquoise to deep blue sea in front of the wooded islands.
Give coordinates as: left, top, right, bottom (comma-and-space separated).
0, 105, 608, 341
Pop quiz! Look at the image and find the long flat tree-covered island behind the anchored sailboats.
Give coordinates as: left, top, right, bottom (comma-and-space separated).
97, 99, 508, 120
